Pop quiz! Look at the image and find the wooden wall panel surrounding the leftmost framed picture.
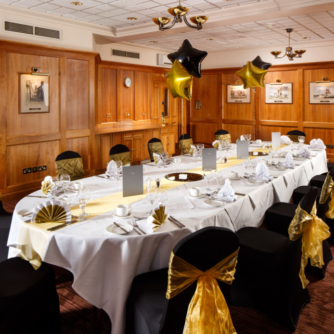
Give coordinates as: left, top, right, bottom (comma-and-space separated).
7, 53, 59, 137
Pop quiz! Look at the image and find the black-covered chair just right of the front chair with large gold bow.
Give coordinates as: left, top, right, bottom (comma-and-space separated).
232, 192, 317, 331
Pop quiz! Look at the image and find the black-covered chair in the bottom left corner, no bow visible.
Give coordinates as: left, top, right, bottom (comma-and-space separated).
0, 257, 60, 334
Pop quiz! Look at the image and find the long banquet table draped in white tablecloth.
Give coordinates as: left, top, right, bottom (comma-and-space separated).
8, 147, 327, 334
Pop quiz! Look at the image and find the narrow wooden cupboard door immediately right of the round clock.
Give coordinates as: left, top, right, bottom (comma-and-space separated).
135, 71, 151, 121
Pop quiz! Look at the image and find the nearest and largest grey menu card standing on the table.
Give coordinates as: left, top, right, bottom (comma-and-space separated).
123, 165, 144, 197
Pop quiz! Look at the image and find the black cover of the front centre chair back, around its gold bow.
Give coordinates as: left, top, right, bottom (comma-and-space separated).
159, 227, 239, 334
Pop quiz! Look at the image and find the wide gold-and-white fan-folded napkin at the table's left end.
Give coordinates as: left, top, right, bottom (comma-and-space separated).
31, 200, 71, 224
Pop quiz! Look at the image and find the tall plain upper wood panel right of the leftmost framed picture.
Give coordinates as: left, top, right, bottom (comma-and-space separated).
66, 59, 89, 130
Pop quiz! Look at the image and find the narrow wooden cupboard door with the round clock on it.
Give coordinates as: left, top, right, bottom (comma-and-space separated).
117, 70, 135, 121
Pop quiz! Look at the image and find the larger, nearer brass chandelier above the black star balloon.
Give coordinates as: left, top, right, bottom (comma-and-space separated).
153, 0, 209, 31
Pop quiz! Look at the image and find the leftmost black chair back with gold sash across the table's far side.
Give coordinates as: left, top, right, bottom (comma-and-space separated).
56, 151, 84, 181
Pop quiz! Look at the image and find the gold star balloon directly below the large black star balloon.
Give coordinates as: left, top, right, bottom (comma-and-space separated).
165, 59, 193, 101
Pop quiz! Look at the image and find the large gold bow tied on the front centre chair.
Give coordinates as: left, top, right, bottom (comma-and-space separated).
166, 249, 239, 334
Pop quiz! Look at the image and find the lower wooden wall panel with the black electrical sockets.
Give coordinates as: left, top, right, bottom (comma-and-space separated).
7, 141, 59, 187
